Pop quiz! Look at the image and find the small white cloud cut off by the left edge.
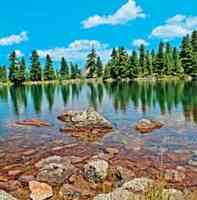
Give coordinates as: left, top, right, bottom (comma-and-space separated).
0, 32, 28, 46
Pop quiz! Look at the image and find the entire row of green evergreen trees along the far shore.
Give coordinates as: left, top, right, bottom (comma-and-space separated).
0, 30, 197, 84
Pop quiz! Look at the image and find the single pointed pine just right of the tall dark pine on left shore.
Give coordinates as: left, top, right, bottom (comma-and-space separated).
44, 54, 55, 81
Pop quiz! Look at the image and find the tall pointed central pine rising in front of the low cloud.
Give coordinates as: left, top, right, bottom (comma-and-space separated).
86, 47, 97, 78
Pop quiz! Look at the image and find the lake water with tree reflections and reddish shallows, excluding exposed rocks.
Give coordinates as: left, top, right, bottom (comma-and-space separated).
0, 81, 197, 200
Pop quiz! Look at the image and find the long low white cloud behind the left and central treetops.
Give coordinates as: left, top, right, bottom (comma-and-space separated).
37, 40, 111, 63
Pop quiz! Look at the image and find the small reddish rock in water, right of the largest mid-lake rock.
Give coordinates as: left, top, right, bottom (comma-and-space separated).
135, 119, 164, 133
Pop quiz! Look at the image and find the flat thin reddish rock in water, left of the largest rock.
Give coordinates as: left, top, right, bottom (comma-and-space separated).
16, 119, 50, 127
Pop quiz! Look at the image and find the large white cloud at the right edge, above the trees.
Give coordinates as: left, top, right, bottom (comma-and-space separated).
151, 15, 197, 39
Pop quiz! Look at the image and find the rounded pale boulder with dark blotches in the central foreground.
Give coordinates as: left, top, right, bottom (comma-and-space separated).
84, 159, 109, 183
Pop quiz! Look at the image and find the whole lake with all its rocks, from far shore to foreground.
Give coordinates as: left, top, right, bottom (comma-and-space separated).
0, 82, 197, 200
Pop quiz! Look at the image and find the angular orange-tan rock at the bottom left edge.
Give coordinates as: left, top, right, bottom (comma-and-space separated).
29, 181, 53, 200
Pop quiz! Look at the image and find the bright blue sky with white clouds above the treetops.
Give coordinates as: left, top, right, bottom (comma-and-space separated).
0, 0, 197, 67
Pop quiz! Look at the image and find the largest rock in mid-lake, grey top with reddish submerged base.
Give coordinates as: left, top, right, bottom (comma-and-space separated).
58, 108, 112, 142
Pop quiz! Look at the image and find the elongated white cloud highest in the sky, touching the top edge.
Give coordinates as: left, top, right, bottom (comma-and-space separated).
82, 0, 145, 28
